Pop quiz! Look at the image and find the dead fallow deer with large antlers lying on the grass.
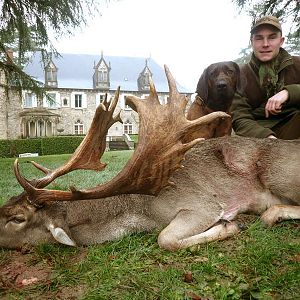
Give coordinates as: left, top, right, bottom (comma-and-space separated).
0, 67, 300, 250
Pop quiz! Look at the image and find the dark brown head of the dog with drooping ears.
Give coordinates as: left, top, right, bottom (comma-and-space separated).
196, 61, 241, 112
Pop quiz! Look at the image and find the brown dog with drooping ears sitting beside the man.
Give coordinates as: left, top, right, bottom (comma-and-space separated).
187, 61, 241, 139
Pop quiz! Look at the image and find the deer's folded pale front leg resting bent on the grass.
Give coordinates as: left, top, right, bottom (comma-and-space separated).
158, 211, 240, 251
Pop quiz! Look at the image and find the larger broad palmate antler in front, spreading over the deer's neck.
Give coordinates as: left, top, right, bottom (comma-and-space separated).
15, 66, 229, 203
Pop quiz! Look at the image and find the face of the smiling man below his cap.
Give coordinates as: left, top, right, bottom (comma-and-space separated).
251, 25, 284, 62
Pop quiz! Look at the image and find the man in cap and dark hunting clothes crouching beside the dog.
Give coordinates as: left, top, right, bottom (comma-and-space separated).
231, 16, 300, 139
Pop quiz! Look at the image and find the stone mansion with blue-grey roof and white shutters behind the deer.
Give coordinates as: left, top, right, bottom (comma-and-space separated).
0, 52, 191, 140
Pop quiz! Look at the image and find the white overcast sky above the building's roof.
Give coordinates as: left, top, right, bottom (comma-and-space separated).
54, 0, 251, 92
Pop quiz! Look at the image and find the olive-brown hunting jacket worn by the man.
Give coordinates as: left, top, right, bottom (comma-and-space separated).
231, 49, 300, 138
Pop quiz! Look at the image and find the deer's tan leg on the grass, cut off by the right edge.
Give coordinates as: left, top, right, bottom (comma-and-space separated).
261, 204, 300, 226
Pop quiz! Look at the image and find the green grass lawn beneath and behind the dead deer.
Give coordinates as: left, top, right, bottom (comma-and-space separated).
0, 151, 300, 300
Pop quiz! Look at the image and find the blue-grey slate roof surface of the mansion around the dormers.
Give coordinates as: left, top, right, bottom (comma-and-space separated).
25, 52, 191, 93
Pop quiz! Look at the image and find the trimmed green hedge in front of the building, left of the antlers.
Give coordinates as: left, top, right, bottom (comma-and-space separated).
0, 136, 84, 157
